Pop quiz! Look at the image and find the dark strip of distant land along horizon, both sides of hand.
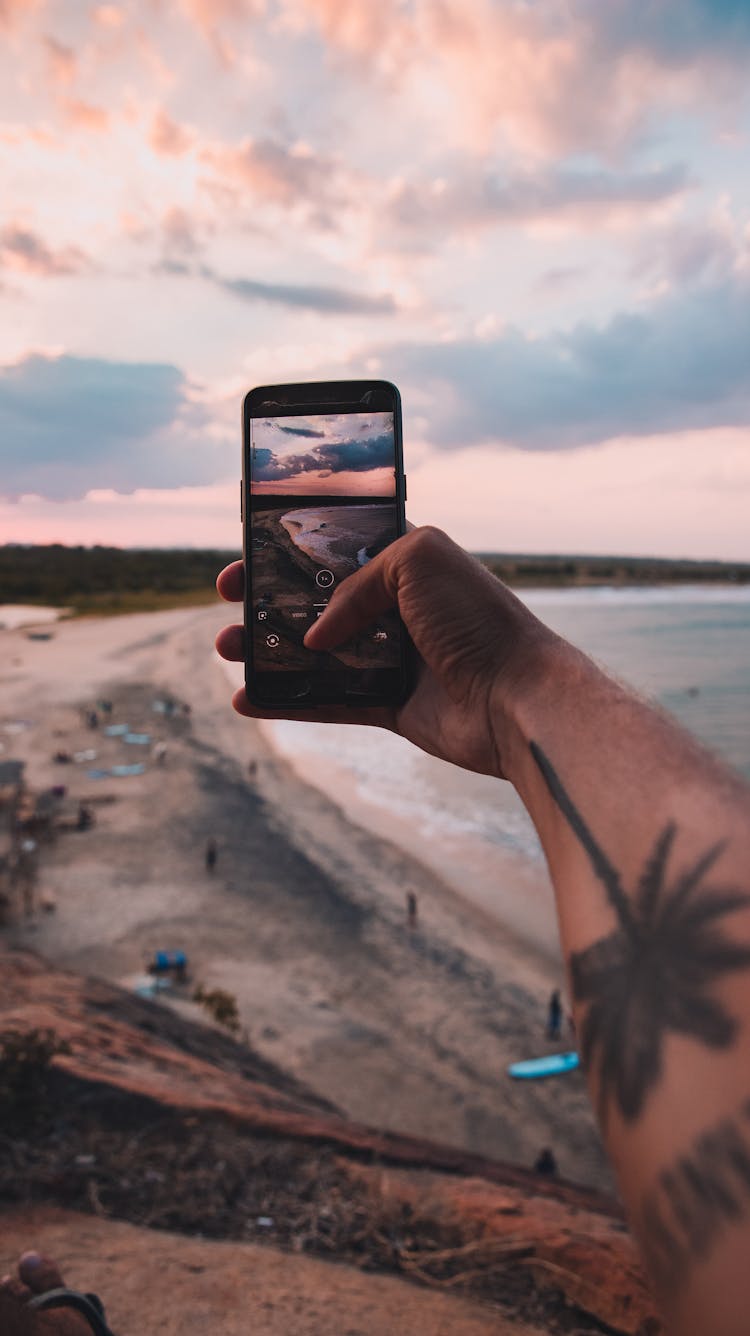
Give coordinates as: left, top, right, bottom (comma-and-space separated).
0, 544, 750, 616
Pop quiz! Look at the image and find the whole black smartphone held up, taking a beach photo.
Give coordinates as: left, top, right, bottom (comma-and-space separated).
242, 381, 409, 709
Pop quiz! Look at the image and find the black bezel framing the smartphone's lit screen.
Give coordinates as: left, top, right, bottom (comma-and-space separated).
242, 379, 412, 709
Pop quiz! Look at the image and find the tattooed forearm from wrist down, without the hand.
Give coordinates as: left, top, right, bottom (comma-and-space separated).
495, 636, 750, 1336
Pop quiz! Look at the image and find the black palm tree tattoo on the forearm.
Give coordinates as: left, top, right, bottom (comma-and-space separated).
531, 743, 750, 1122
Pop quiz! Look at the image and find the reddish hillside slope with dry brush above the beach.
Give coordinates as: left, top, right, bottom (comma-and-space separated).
0, 951, 659, 1336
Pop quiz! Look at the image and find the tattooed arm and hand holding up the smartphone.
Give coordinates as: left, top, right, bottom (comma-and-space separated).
217, 526, 750, 1336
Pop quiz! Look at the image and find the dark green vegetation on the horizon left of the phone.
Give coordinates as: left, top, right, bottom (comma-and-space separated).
0, 544, 238, 616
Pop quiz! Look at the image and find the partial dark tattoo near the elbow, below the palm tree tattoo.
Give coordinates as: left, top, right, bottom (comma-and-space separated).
634, 1100, 750, 1292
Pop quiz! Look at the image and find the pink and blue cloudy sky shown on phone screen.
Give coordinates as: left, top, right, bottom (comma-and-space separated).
250, 413, 396, 497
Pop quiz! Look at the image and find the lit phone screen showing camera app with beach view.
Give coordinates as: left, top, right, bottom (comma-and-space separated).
249, 413, 401, 672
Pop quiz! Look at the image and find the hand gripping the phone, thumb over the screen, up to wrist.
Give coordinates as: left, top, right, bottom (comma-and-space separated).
217, 528, 556, 775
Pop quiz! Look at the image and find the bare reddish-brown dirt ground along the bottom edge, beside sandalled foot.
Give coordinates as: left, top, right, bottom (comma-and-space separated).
0, 1208, 540, 1336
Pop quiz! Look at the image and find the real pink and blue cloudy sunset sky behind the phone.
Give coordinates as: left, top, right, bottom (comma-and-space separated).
0, 0, 750, 561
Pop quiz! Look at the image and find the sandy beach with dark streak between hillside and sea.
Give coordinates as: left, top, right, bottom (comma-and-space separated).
0, 604, 611, 1189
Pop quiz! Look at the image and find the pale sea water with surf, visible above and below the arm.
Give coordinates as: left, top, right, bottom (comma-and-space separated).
250, 587, 750, 953
